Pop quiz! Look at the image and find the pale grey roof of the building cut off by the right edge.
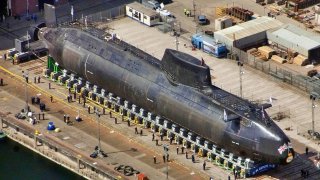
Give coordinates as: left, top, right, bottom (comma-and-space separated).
269, 24, 320, 50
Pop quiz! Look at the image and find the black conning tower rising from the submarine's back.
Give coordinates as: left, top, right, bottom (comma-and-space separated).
161, 49, 211, 89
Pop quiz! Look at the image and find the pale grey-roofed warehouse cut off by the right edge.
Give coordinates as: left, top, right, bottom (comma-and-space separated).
267, 24, 320, 62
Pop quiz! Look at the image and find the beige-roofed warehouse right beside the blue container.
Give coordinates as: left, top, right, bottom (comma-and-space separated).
214, 16, 282, 50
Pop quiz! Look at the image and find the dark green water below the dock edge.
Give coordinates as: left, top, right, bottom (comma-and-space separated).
0, 138, 84, 180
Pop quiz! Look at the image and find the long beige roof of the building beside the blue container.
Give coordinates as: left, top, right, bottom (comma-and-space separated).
215, 16, 282, 40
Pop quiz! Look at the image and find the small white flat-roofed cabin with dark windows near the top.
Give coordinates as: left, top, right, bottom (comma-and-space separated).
126, 2, 160, 26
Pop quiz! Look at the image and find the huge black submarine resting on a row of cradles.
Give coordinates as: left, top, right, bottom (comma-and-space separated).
34, 27, 294, 165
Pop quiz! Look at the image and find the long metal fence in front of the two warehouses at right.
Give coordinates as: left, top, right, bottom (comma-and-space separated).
228, 48, 320, 94
